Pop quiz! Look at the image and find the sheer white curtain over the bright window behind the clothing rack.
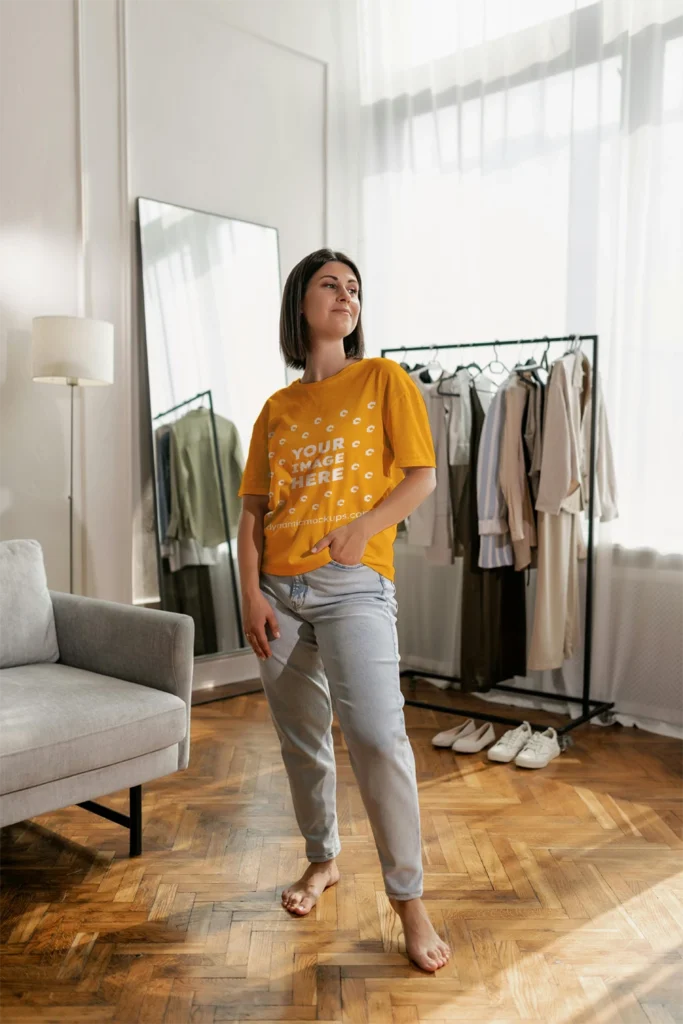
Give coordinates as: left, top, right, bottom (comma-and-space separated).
358, 0, 683, 728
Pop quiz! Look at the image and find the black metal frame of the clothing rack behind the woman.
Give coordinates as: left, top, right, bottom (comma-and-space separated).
382, 334, 614, 749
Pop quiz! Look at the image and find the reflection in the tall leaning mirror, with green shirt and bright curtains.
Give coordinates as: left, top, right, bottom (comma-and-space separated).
138, 199, 286, 657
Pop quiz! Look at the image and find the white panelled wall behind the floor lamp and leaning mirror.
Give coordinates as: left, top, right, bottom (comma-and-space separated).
0, 0, 357, 601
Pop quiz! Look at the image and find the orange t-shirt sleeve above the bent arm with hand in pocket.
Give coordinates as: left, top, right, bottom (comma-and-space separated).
384, 364, 436, 469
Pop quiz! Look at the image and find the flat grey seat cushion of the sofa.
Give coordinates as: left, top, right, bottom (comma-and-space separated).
0, 665, 186, 795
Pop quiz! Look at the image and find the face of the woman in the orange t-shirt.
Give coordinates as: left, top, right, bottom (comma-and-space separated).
302, 262, 360, 341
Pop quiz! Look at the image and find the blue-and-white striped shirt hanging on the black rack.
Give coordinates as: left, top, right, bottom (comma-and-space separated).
477, 378, 514, 569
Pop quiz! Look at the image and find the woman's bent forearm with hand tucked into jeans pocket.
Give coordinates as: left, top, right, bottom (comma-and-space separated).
311, 466, 436, 565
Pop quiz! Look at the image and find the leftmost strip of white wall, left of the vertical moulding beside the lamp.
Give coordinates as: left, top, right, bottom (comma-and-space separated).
0, 0, 79, 589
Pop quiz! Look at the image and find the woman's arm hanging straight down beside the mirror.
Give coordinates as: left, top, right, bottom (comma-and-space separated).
238, 495, 280, 659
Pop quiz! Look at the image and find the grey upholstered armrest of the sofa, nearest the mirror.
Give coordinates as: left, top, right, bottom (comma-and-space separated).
50, 591, 195, 769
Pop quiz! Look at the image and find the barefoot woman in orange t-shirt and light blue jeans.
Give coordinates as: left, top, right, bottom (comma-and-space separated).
239, 250, 451, 971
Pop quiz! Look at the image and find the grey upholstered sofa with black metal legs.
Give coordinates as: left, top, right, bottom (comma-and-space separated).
0, 542, 195, 856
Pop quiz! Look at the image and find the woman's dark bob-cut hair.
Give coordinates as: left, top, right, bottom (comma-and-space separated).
280, 249, 366, 370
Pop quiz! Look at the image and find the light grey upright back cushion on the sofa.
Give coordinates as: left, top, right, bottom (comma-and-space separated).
0, 541, 59, 669
